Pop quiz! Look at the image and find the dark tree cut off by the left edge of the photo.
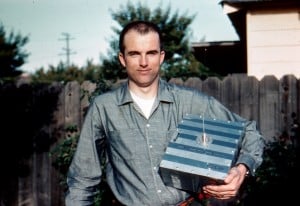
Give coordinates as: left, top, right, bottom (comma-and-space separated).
0, 25, 29, 79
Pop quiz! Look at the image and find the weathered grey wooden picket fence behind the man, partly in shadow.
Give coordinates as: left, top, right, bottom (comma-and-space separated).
0, 75, 300, 206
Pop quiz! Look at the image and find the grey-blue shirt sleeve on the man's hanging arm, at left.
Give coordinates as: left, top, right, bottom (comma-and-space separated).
65, 100, 103, 206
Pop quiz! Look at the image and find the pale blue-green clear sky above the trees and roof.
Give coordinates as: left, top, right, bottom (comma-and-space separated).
0, 0, 238, 73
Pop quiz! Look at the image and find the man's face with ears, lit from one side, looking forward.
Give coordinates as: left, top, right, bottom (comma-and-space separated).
119, 31, 165, 87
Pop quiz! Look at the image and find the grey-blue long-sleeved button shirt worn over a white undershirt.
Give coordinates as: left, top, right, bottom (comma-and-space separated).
66, 79, 264, 206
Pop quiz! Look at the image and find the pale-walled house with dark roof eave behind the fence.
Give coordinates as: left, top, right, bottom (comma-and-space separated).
220, 0, 300, 79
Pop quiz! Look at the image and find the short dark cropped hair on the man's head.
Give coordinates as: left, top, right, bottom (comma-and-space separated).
119, 20, 163, 53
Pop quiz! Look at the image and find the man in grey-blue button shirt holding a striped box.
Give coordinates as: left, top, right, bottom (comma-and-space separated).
66, 21, 264, 206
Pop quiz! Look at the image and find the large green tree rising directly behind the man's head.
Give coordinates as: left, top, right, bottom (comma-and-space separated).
101, 2, 213, 80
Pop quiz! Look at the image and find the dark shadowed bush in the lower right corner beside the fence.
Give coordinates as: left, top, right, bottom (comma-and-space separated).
240, 122, 300, 206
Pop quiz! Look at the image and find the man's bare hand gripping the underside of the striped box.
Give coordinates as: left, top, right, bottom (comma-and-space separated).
203, 164, 248, 199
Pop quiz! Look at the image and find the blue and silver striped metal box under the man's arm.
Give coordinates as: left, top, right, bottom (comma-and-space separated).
160, 114, 245, 192
